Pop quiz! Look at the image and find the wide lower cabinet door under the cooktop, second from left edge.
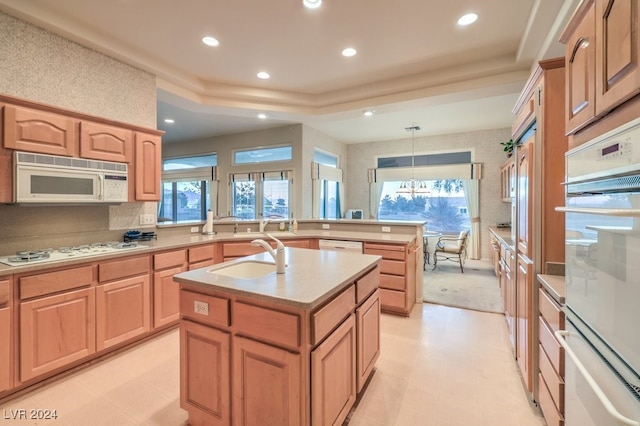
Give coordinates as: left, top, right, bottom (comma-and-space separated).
20, 288, 96, 381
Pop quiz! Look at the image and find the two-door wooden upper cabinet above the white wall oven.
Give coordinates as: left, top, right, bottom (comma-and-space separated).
560, 0, 640, 134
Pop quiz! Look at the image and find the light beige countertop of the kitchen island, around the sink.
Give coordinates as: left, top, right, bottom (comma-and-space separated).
174, 247, 381, 309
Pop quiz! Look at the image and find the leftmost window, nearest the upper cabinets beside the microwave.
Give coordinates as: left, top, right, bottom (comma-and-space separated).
158, 154, 217, 223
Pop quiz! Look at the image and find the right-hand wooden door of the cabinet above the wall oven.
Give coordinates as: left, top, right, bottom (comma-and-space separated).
596, 0, 640, 113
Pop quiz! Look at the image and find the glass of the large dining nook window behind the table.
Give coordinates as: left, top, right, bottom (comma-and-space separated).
378, 179, 471, 234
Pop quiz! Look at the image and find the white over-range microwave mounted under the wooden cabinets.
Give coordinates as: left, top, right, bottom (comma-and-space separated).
13, 152, 129, 204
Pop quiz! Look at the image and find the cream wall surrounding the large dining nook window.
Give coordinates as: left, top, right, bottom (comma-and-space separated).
347, 128, 511, 258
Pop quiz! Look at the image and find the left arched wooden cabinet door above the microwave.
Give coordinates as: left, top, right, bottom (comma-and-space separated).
3, 105, 78, 157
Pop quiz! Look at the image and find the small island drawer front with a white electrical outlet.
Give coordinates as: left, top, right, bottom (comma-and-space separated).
180, 290, 230, 327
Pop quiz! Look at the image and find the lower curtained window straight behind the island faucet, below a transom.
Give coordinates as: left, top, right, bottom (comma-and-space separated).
230, 171, 291, 220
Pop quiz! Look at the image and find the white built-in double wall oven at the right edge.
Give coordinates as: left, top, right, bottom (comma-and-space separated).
556, 119, 640, 426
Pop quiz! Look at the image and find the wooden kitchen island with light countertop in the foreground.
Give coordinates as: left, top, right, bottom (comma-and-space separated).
174, 247, 381, 425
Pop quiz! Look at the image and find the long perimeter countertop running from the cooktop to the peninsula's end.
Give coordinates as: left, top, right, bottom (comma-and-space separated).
0, 229, 416, 277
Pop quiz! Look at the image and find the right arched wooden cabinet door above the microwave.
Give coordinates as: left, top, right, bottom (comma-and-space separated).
80, 121, 133, 163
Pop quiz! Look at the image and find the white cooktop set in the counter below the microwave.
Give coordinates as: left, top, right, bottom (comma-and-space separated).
0, 241, 145, 266
